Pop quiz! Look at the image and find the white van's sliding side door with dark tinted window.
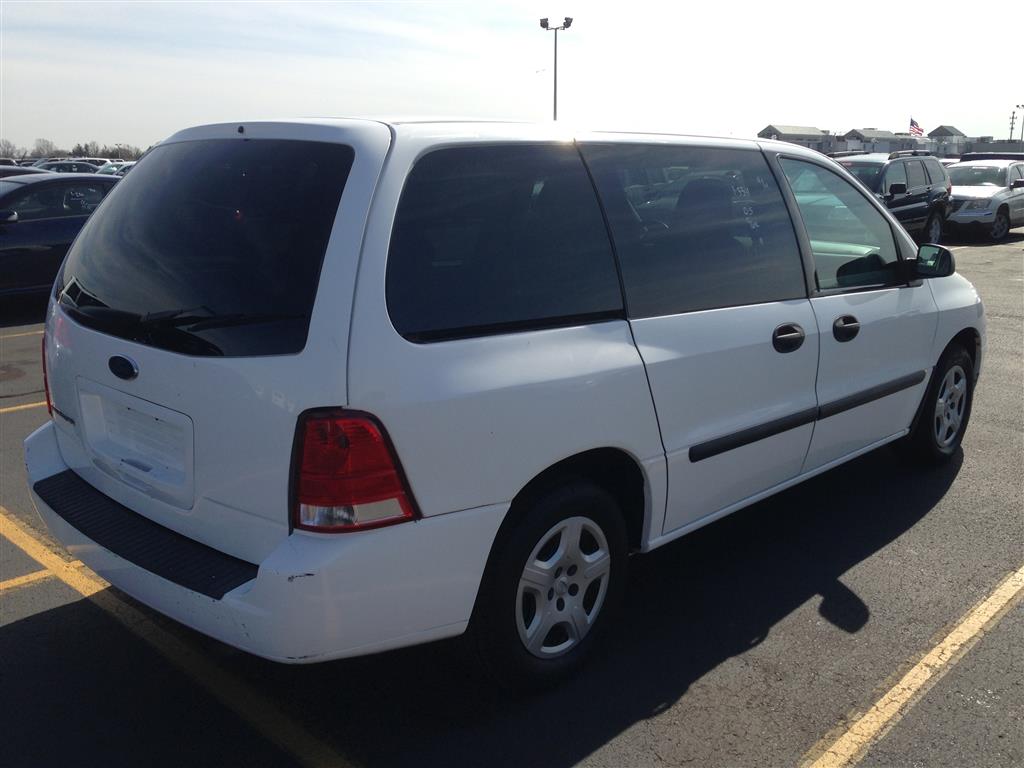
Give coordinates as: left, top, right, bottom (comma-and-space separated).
582, 143, 818, 532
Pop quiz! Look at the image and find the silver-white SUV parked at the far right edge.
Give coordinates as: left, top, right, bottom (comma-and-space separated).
946, 153, 1024, 241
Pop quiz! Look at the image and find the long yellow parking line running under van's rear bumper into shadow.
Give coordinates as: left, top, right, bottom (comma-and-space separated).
0, 506, 352, 768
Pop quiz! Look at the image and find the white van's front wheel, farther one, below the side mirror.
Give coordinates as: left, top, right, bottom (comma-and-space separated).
906, 344, 974, 464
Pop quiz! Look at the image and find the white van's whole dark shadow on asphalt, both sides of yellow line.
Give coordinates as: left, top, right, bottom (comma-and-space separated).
0, 449, 963, 768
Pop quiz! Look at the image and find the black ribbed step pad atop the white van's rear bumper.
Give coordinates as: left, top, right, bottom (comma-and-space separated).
33, 469, 258, 600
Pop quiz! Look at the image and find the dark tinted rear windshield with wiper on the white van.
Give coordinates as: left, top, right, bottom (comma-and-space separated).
56, 139, 354, 356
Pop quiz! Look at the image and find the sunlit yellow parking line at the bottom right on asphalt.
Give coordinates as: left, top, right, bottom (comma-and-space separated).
802, 566, 1024, 768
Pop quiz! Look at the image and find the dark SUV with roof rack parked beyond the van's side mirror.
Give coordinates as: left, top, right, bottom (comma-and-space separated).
835, 150, 952, 243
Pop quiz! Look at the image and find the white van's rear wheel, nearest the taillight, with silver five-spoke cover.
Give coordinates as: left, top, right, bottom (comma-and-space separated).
471, 480, 628, 690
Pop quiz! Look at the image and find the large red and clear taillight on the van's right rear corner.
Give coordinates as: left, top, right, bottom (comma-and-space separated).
292, 411, 416, 532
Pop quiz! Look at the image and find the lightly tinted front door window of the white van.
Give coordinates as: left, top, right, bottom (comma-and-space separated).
779, 158, 900, 290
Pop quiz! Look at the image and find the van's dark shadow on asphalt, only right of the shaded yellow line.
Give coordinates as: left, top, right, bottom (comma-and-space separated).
240, 450, 963, 768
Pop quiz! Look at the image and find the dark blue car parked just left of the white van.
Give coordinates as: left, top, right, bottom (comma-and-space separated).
0, 173, 119, 296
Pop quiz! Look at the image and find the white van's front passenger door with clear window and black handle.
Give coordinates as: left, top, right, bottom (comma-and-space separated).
780, 158, 938, 471
